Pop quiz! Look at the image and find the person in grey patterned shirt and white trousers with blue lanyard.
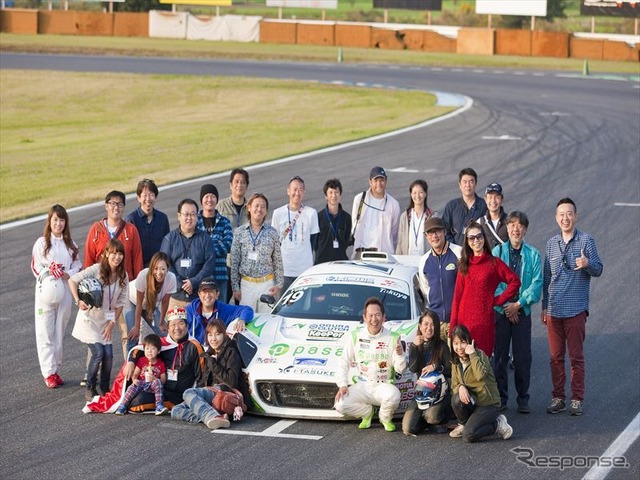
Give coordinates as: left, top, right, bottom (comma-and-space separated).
231, 193, 284, 313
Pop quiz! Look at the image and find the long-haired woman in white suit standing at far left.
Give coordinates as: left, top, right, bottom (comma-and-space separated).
31, 205, 82, 388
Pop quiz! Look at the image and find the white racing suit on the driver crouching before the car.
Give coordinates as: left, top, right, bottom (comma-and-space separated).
335, 326, 407, 422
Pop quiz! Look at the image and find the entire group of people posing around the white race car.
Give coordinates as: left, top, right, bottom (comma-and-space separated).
32, 167, 602, 438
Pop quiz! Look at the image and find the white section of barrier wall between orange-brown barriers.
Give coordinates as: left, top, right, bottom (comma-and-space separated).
149, 10, 262, 42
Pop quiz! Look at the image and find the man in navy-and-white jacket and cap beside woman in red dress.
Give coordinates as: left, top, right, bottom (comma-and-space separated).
418, 214, 462, 341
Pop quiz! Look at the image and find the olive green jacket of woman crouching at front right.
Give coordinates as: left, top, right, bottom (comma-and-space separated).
451, 350, 500, 407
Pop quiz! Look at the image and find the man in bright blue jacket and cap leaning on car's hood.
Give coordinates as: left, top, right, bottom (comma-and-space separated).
185, 277, 253, 346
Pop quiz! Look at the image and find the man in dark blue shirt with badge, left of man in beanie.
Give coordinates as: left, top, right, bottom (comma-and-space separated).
160, 198, 215, 308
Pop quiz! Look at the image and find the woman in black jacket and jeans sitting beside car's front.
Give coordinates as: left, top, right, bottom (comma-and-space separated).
171, 318, 249, 430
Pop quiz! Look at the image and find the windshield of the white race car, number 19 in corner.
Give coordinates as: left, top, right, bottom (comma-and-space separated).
272, 283, 411, 322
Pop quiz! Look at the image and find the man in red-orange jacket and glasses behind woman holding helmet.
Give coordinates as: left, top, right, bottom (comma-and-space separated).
83, 190, 142, 358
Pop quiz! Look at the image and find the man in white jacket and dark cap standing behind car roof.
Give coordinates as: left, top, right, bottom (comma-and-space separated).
351, 167, 400, 258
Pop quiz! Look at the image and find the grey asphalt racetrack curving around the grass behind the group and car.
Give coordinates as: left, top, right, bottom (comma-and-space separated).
0, 54, 640, 479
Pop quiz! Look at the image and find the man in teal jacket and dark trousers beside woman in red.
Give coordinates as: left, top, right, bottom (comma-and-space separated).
493, 211, 542, 413
